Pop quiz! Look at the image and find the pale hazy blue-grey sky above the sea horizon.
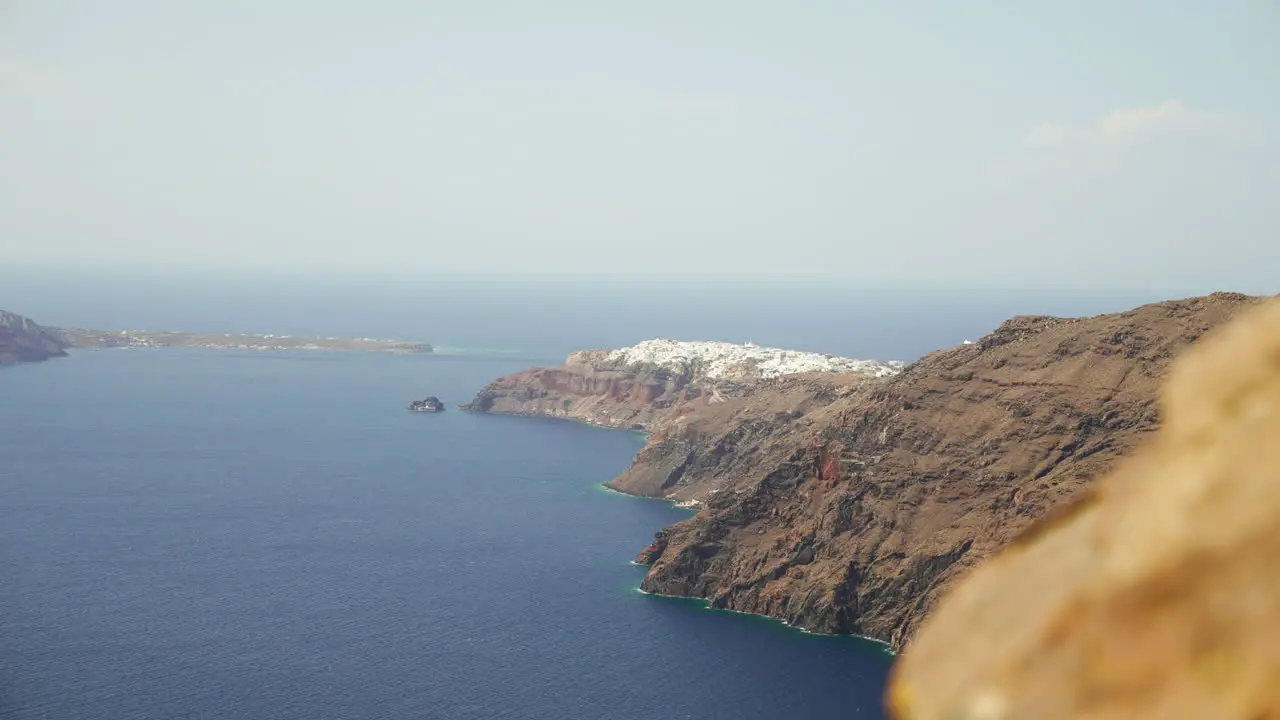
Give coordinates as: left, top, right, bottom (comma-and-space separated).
0, 0, 1280, 292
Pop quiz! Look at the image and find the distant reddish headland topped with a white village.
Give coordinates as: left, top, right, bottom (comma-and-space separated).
462, 340, 901, 432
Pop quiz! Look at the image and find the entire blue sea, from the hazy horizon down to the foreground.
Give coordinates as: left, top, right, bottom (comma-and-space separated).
0, 270, 1198, 720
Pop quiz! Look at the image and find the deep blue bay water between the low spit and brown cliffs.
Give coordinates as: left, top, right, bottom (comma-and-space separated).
0, 351, 888, 720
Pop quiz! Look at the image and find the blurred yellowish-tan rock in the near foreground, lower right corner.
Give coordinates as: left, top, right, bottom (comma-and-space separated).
890, 293, 1280, 720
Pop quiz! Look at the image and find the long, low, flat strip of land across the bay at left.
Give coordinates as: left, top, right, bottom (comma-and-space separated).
47, 328, 433, 354
